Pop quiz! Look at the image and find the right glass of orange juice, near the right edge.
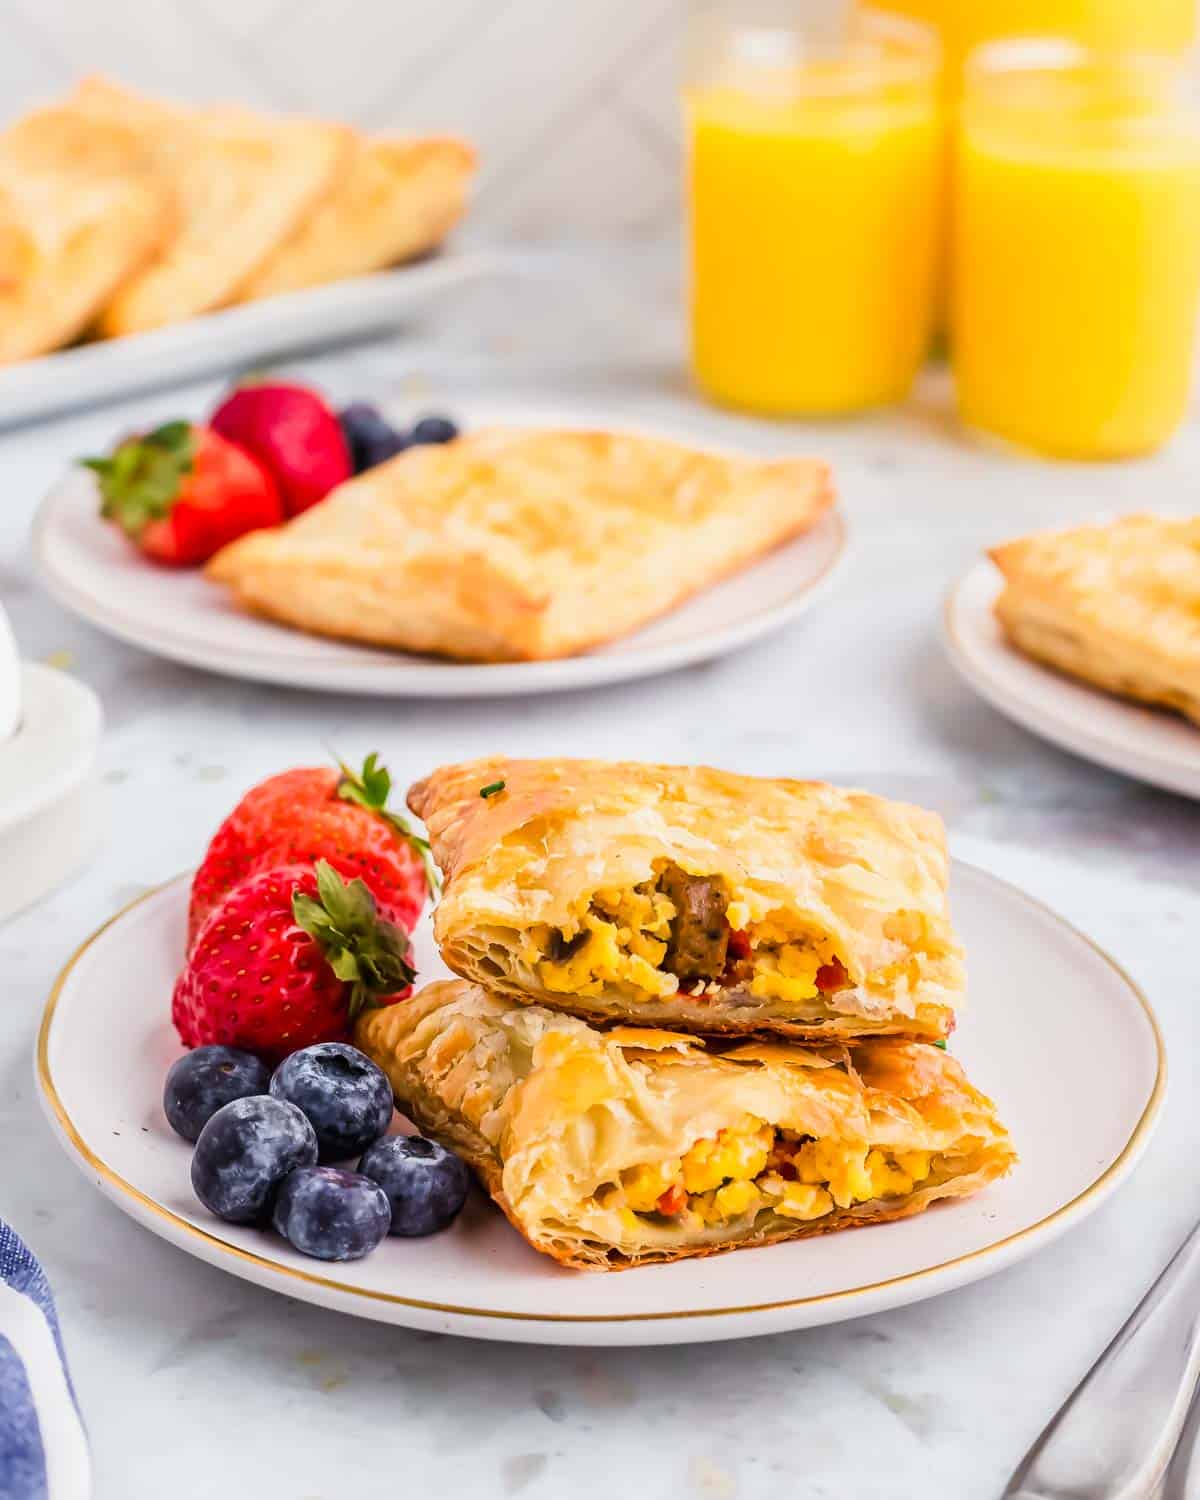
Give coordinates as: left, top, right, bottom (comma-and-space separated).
951, 41, 1200, 459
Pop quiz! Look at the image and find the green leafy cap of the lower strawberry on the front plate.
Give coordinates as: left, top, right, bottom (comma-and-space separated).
291, 860, 417, 1020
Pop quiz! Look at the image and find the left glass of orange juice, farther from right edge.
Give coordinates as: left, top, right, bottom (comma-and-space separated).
684, 0, 944, 416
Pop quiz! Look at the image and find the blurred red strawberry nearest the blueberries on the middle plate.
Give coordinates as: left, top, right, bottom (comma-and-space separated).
212, 384, 354, 516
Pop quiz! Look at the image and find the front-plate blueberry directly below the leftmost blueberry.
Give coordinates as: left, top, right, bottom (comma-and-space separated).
192, 1094, 317, 1224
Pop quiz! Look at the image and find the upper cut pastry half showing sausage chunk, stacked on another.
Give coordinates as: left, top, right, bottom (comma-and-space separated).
408, 758, 965, 1040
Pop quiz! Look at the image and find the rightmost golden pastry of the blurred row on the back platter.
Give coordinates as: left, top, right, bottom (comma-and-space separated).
242, 137, 476, 302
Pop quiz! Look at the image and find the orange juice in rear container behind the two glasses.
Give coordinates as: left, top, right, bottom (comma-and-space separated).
879, 0, 1197, 78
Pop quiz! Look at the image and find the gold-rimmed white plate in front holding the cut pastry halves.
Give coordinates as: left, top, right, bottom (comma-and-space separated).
38, 863, 1164, 1344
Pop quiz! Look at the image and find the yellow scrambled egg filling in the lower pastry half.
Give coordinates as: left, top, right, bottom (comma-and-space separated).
599, 1115, 933, 1226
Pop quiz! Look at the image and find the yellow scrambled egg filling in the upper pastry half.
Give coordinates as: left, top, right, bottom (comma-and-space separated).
522, 872, 848, 1005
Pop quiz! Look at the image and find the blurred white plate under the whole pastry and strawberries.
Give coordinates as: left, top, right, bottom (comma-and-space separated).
33, 447, 846, 698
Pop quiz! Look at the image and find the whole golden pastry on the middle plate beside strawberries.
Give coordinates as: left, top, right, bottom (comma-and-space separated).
209, 429, 833, 662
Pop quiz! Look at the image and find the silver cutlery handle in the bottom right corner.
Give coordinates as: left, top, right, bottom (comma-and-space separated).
1004, 1224, 1200, 1500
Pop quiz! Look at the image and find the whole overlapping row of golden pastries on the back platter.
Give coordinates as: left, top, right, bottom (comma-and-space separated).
0, 78, 474, 363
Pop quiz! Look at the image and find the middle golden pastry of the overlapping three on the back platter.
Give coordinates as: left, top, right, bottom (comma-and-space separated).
69, 78, 354, 335
